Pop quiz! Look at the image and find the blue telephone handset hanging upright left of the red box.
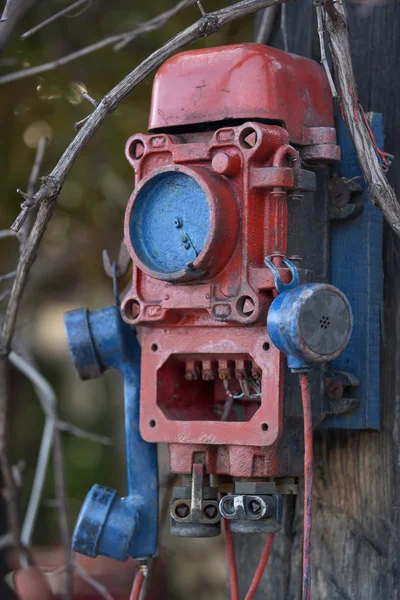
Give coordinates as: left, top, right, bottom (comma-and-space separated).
65, 306, 158, 561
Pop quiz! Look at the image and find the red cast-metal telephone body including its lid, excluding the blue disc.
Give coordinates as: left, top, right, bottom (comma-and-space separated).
122, 44, 339, 478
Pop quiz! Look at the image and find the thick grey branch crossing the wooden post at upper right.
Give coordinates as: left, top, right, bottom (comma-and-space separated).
324, 0, 400, 235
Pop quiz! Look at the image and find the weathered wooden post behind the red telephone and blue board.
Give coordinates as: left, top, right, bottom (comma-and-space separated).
235, 1, 400, 600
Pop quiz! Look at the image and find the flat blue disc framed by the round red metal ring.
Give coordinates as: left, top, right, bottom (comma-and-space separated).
130, 171, 210, 273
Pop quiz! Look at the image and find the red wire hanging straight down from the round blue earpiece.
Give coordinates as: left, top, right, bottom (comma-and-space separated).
300, 373, 313, 600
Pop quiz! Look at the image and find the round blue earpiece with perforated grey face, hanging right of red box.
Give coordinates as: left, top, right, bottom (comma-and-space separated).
267, 283, 353, 372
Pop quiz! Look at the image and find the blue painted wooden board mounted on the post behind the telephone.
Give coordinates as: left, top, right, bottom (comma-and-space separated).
322, 114, 384, 430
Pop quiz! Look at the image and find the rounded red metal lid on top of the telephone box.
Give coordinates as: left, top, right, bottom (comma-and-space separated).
149, 44, 334, 144
